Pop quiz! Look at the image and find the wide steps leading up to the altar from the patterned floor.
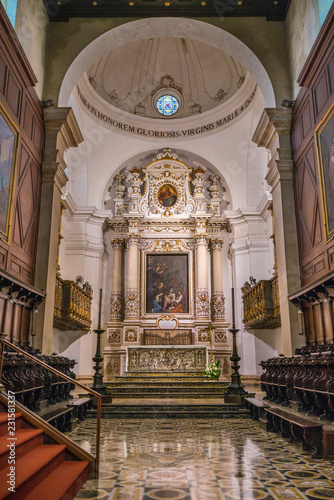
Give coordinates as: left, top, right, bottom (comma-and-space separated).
87, 372, 249, 418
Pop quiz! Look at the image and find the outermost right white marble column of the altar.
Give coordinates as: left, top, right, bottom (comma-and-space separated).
211, 239, 225, 321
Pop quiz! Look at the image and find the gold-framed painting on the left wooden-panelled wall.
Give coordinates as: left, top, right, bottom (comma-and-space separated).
0, 105, 19, 243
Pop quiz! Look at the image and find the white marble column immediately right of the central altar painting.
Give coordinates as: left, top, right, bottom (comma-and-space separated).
196, 234, 210, 319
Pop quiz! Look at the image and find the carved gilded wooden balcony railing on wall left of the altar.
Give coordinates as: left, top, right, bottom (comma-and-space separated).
53, 274, 93, 331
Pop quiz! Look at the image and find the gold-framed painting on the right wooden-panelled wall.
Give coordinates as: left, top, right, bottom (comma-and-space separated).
316, 106, 334, 240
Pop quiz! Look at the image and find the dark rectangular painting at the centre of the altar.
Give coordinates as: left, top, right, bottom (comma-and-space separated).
146, 254, 189, 314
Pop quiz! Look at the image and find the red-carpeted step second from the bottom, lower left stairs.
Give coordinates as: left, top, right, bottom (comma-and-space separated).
0, 444, 66, 500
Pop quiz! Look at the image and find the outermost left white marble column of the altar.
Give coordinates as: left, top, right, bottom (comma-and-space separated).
110, 239, 124, 321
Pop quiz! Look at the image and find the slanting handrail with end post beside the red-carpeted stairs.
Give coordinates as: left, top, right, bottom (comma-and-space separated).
0, 339, 102, 477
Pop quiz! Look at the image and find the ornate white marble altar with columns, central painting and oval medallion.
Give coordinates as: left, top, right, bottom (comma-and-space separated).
103, 148, 231, 382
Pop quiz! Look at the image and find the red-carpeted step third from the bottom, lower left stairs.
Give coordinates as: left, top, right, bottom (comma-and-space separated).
0, 429, 43, 470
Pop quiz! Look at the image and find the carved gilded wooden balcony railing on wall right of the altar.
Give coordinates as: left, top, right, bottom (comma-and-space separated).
241, 275, 281, 330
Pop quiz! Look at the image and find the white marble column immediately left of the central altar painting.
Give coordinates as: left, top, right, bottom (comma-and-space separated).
125, 234, 139, 319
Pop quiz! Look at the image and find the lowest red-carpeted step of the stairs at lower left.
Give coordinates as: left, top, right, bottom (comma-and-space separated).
24, 461, 89, 500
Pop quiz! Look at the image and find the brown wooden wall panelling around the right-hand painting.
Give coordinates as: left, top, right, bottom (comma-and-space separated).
291, 3, 334, 286
